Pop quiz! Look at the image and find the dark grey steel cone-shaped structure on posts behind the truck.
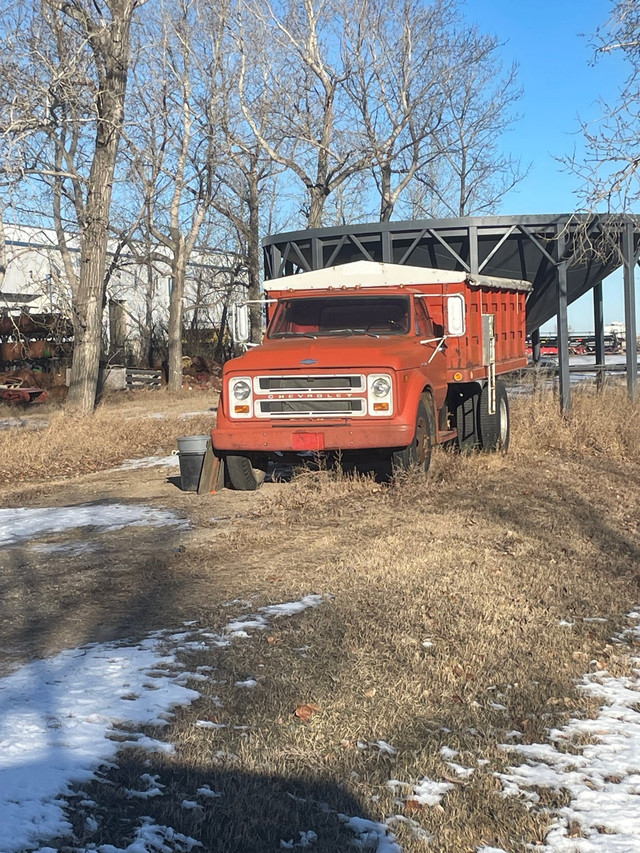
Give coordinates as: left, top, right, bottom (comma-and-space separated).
263, 214, 640, 410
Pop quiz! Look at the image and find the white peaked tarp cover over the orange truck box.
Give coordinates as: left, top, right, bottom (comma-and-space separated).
264, 261, 532, 292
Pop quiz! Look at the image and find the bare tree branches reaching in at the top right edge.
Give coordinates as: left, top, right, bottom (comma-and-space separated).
564, 0, 640, 213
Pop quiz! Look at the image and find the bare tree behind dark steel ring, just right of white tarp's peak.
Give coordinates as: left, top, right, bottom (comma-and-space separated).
344, 0, 460, 222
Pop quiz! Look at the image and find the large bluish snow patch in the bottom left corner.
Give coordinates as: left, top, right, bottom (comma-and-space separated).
0, 641, 199, 853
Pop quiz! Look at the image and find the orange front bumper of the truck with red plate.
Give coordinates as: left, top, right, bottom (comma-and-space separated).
211, 419, 415, 453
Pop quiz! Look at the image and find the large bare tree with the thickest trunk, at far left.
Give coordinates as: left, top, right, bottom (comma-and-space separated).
2, 0, 144, 414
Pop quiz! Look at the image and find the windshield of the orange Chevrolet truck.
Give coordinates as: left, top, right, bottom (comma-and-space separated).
269, 296, 409, 338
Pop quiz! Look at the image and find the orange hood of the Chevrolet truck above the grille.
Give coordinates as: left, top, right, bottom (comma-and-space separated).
224, 335, 430, 374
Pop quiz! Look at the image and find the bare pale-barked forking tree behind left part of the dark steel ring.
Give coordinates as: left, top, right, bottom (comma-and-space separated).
236, 0, 371, 228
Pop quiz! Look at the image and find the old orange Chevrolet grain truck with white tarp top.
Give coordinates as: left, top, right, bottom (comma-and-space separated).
212, 261, 531, 490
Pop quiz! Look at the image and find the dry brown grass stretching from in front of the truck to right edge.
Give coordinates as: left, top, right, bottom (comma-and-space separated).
3, 392, 640, 853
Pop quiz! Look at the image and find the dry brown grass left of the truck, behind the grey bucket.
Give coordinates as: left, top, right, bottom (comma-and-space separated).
0, 390, 217, 485
